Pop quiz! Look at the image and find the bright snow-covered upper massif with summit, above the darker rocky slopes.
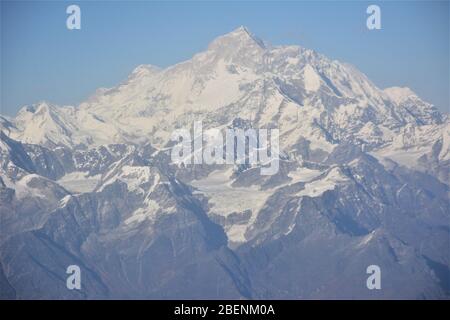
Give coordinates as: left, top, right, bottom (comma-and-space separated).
2, 27, 445, 162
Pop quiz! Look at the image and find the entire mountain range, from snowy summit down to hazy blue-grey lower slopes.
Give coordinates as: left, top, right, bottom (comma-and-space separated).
0, 27, 450, 299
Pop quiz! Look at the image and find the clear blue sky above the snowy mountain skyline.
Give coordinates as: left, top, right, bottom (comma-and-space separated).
0, 1, 450, 116
